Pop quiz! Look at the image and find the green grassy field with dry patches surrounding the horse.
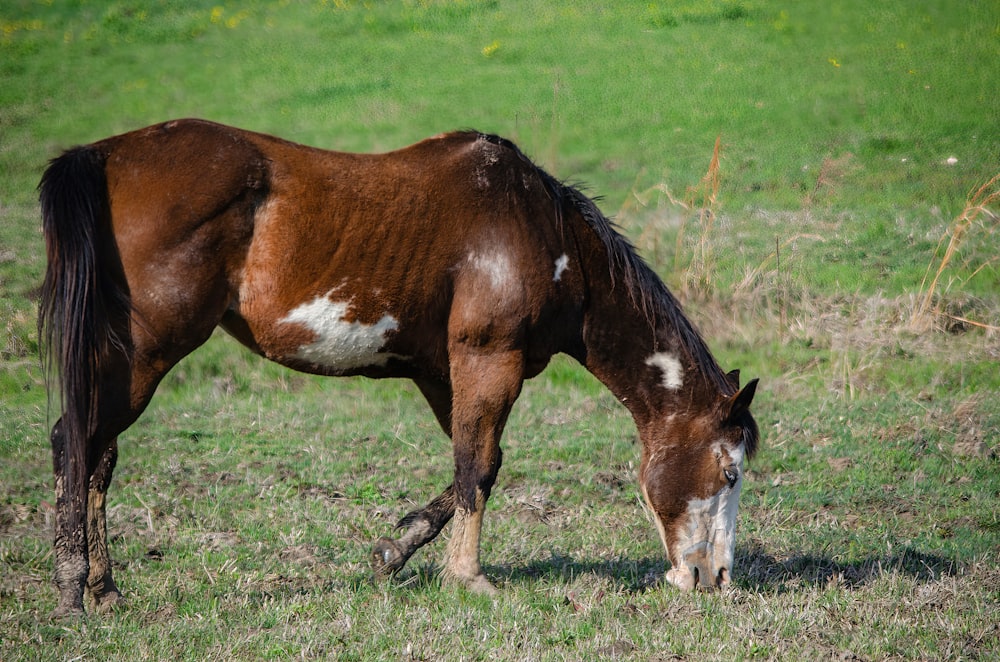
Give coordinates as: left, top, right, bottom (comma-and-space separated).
0, 0, 1000, 660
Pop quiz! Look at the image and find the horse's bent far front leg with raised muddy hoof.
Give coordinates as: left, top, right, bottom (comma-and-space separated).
371, 379, 455, 577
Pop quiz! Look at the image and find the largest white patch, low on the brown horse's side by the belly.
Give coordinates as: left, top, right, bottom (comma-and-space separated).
281, 296, 399, 370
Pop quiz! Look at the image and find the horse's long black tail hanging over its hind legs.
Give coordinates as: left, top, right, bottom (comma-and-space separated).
38, 146, 130, 498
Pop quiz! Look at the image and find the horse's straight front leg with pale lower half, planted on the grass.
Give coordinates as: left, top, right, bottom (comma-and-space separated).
444, 346, 524, 593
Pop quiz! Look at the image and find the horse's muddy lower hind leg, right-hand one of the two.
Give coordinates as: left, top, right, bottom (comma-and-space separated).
87, 438, 122, 612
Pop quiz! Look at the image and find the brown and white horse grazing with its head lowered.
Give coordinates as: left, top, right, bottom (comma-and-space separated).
39, 120, 758, 615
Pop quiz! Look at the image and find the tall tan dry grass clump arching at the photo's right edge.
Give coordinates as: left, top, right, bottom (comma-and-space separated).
910, 174, 1000, 331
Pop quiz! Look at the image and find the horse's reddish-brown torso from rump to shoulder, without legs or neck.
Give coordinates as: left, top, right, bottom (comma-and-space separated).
91, 120, 575, 382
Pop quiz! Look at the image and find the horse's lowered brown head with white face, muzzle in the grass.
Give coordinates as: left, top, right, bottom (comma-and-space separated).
639, 380, 757, 589
